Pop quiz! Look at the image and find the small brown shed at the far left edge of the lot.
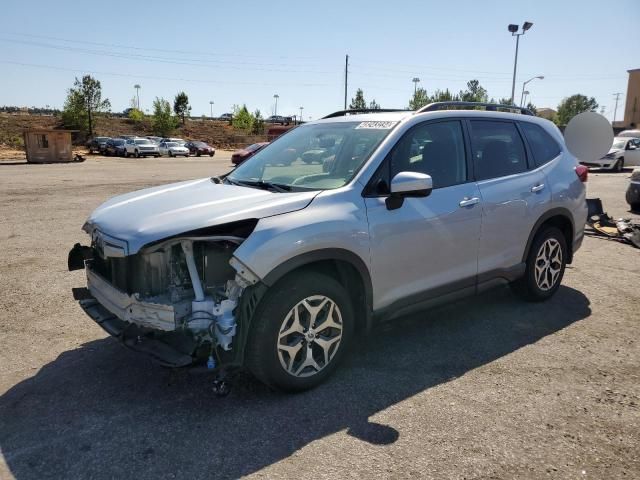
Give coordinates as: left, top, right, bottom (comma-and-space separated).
24, 128, 73, 163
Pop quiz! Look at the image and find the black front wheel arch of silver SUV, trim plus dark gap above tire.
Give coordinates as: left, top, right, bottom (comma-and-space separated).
262, 248, 373, 331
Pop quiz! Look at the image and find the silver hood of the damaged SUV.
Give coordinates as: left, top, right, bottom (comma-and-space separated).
83, 178, 318, 255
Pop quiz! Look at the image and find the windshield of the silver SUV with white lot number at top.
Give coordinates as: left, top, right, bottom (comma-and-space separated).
227, 122, 397, 190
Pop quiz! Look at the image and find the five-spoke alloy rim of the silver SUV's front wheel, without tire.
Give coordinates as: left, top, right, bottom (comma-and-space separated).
277, 295, 343, 377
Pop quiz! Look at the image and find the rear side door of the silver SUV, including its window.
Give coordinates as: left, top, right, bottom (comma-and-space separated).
468, 120, 551, 282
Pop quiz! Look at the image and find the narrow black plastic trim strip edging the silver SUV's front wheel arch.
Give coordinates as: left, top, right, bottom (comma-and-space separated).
262, 248, 373, 331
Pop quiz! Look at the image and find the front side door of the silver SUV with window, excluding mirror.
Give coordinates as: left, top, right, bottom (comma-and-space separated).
365, 120, 481, 310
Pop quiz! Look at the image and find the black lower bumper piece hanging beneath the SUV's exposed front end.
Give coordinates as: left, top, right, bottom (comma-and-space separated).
74, 289, 195, 367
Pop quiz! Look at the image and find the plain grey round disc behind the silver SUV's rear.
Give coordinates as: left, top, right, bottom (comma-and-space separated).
564, 112, 613, 163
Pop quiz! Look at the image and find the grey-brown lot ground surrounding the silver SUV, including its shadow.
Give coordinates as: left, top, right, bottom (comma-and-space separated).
0, 156, 640, 479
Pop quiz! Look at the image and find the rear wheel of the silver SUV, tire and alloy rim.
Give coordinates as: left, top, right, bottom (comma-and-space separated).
511, 226, 568, 302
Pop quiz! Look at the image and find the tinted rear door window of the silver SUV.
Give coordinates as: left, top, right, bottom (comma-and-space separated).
469, 120, 527, 180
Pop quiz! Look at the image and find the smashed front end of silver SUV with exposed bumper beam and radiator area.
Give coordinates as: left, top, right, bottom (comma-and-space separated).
68, 221, 260, 369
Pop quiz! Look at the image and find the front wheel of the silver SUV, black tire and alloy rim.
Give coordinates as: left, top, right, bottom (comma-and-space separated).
246, 272, 355, 391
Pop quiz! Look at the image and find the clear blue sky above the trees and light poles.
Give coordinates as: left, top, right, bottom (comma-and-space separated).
0, 0, 640, 119
